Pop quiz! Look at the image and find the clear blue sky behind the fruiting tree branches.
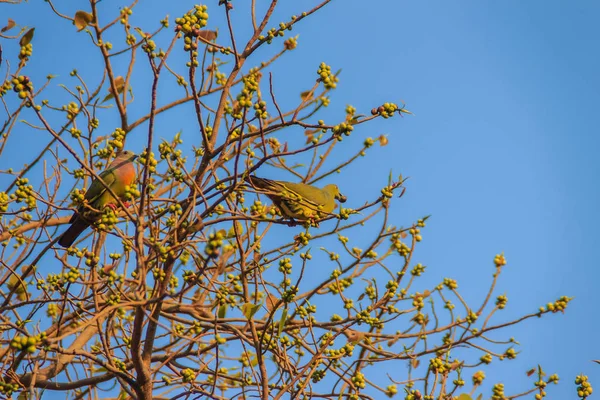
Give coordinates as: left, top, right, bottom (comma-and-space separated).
0, 0, 600, 399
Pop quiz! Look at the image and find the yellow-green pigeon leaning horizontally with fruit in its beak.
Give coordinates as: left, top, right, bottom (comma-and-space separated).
246, 176, 346, 221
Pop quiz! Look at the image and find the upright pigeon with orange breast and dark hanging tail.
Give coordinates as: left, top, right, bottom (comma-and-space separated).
58, 150, 137, 247
